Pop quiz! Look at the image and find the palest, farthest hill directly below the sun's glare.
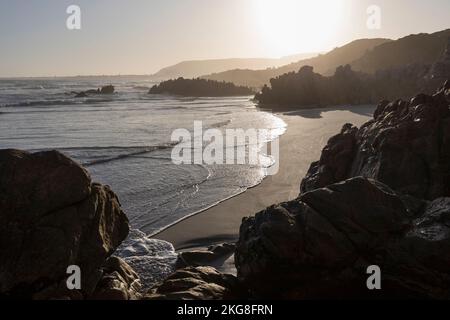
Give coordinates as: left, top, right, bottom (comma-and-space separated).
152, 53, 317, 81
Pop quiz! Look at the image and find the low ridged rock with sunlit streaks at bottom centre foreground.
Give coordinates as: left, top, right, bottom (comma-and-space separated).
144, 267, 239, 300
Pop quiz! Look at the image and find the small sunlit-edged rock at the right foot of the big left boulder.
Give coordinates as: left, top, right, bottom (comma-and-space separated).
91, 256, 141, 300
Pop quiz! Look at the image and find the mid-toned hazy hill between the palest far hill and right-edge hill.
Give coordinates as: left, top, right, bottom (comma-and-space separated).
202, 39, 392, 88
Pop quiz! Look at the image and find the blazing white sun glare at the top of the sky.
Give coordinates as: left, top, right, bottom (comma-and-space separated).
253, 0, 343, 56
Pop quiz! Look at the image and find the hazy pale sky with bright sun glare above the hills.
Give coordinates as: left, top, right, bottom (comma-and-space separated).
0, 0, 450, 76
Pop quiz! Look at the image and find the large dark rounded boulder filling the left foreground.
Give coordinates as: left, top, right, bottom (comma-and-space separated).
0, 150, 129, 299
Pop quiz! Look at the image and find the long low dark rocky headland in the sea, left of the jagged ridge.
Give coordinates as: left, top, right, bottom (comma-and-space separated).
149, 78, 255, 97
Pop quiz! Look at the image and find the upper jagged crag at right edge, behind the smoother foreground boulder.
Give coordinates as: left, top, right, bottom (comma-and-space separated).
301, 83, 450, 200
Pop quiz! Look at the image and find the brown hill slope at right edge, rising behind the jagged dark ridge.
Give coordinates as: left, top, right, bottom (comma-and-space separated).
352, 29, 450, 73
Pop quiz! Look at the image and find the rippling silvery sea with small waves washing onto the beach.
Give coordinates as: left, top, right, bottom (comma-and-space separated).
0, 77, 286, 288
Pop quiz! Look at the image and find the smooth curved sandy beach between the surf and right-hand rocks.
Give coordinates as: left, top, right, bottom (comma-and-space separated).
154, 106, 374, 250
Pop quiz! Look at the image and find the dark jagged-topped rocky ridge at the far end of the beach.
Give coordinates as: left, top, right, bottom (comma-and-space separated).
255, 55, 450, 108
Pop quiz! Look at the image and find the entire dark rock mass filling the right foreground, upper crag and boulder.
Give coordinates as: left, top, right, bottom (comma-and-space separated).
235, 82, 450, 299
